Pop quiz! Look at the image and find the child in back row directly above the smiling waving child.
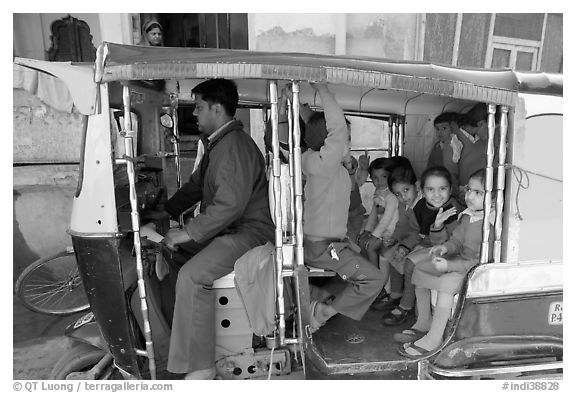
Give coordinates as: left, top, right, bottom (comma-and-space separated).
426, 112, 464, 196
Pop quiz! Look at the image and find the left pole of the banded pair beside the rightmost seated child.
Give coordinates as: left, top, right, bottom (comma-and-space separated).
480, 104, 496, 263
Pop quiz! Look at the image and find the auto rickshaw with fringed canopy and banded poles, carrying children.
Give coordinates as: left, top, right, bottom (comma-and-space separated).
15, 43, 563, 379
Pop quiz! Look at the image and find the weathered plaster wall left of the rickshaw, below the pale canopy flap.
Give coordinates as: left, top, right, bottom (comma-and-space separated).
12, 89, 82, 280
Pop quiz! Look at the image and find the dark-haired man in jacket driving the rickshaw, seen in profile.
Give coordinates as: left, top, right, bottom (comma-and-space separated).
150, 79, 274, 379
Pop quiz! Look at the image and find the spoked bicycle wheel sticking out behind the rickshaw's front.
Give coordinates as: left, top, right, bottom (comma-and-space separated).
15, 247, 90, 315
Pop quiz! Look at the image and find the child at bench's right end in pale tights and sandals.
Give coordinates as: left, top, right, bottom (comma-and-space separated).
399, 169, 493, 358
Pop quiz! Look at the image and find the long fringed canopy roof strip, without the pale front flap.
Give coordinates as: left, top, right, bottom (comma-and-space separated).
102, 43, 563, 99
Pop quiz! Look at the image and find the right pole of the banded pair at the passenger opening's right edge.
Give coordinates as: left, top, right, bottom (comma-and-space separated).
494, 106, 508, 263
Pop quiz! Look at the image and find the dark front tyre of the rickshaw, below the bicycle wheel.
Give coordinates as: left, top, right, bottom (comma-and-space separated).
50, 343, 110, 380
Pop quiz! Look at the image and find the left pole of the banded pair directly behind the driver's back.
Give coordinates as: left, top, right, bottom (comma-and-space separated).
270, 81, 286, 345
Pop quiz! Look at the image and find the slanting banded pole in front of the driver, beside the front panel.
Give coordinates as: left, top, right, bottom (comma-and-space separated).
122, 86, 156, 379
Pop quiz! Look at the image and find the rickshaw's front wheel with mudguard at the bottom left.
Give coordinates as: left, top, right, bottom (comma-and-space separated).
50, 342, 113, 380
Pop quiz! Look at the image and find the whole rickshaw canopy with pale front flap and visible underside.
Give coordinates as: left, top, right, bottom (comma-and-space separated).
14, 43, 563, 114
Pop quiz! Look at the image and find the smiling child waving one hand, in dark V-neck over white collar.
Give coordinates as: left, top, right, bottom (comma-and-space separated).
382, 167, 462, 326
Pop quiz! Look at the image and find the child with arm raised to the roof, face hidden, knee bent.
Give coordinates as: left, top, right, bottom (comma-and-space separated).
302, 84, 384, 332
